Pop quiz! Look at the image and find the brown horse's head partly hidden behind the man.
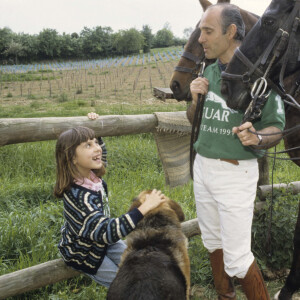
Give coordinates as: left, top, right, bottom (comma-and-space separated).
170, 0, 258, 101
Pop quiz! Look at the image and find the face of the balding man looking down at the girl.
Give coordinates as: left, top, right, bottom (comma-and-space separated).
198, 8, 230, 61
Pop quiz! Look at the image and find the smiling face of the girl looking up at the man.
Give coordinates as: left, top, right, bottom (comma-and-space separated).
73, 138, 103, 178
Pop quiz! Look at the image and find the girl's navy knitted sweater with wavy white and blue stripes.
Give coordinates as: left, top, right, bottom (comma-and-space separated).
58, 181, 143, 274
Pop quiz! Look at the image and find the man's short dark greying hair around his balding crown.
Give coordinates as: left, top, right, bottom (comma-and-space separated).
220, 3, 245, 41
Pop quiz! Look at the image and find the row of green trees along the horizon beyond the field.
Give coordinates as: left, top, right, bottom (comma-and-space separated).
0, 24, 192, 64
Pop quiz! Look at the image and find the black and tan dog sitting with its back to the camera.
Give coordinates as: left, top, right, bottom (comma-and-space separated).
107, 191, 190, 300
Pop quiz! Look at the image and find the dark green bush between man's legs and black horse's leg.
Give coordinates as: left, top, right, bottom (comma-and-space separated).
252, 191, 299, 270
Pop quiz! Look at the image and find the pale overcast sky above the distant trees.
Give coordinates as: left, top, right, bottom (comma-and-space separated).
0, 0, 271, 38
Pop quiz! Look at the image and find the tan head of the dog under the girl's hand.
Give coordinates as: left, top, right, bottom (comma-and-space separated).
129, 190, 184, 222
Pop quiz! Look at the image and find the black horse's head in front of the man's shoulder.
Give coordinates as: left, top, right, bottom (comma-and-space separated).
221, 0, 300, 111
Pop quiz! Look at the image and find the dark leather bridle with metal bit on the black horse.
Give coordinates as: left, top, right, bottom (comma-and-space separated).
222, 0, 300, 110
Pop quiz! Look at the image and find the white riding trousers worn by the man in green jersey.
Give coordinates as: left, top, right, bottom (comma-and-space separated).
194, 154, 258, 278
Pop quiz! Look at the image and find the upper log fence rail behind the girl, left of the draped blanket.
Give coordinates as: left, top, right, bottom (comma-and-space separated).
0, 112, 161, 146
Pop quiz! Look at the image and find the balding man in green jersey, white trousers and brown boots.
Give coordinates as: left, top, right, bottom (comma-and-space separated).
187, 4, 285, 300
